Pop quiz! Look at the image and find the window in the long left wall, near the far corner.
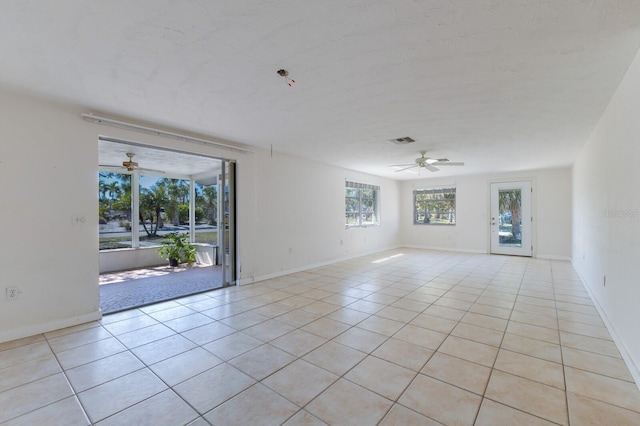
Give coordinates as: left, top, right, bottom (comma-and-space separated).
344, 181, 380, 227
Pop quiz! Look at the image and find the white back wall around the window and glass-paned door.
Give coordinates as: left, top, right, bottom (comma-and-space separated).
400, 168, 571, 260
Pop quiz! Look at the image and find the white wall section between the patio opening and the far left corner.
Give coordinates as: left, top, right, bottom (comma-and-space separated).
242, 149, 399, 281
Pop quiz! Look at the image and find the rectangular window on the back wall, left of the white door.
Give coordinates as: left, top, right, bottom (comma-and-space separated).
413, 188, 456, 225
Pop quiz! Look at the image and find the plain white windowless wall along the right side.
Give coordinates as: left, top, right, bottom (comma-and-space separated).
573, 48, 640, 377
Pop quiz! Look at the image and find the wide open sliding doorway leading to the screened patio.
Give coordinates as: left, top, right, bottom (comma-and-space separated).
98, 137, 236, 313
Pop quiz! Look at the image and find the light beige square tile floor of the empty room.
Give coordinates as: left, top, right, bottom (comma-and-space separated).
0, 249, 640, 426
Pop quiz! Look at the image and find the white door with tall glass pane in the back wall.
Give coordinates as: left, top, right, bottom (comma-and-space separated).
490, 181, 533, 256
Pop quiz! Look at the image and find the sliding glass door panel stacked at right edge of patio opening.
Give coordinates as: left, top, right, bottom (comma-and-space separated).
218, 161, 236, 286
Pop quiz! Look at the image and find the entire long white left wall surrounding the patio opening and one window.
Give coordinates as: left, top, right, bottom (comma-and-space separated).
0, 92, 398, 342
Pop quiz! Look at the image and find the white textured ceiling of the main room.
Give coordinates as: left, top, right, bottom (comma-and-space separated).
0, 0, 640, 179
